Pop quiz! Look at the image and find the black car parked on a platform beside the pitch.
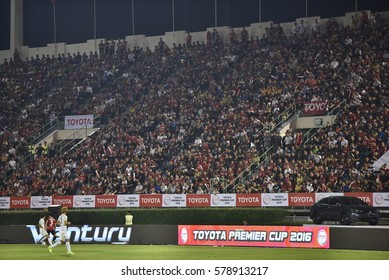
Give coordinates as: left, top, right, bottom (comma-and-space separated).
309, 196, 380, 225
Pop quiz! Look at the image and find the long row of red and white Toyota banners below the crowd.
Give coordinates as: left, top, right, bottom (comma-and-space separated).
0, 192, 389, 209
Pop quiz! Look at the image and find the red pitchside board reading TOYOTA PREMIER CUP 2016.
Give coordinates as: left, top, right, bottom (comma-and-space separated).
178, 225, 330, 249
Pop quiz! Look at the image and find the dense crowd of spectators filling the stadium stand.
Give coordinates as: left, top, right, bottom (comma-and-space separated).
0, 14, 389, 196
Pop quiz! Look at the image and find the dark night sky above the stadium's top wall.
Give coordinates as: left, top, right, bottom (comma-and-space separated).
0, 0, 389, 50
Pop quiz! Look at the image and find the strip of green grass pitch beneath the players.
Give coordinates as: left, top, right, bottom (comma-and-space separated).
0, 244, 389, 260
